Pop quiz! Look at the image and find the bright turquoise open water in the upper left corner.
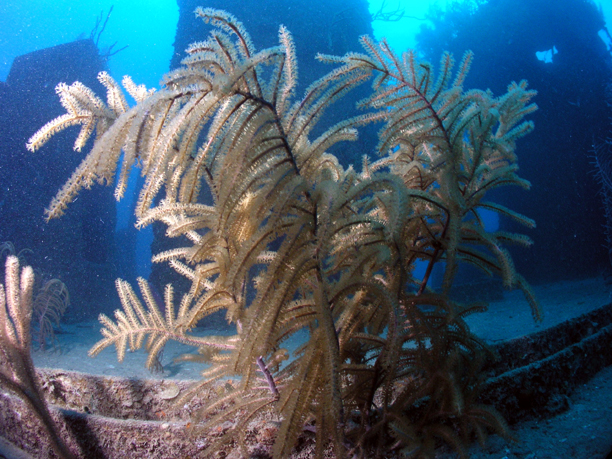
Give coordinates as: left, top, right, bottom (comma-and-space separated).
0, 0, 178, 87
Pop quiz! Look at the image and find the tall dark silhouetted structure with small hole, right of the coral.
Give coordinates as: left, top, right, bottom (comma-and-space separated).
418, 0, 612, 282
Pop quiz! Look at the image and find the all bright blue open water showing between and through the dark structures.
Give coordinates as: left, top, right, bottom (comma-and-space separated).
0, 0, 612, 306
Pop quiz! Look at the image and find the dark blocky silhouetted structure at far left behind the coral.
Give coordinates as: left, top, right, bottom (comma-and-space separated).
0, 40, 117, 318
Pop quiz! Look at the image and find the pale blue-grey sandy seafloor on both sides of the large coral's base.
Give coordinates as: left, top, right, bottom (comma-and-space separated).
33, 277, 612, 459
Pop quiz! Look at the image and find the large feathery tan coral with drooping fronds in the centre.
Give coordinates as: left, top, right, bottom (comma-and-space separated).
28, 8, 540, 458
